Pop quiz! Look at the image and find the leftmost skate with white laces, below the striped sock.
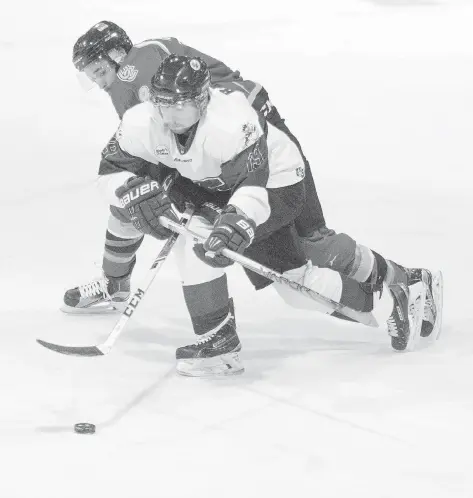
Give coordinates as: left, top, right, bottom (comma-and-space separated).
61, 274, 131, 314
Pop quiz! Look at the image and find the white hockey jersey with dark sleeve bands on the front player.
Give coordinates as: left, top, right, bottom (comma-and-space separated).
99, 89, 304, 225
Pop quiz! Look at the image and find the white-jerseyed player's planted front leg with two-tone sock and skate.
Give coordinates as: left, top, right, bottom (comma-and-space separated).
173, 216, 244, 377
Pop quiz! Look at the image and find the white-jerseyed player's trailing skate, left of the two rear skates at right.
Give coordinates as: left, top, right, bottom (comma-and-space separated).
387, 274, 425, 351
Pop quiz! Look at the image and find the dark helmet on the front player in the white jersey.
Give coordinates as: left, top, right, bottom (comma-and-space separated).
150, 54, 210, 106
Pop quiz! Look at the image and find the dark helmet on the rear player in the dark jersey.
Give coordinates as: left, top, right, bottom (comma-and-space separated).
72, 21, 133, 71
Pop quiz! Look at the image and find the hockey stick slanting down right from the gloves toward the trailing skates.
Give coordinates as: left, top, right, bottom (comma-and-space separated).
159, 216, 378, 327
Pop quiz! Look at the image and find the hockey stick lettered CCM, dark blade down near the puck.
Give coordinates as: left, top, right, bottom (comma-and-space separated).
36, 208, 193, 356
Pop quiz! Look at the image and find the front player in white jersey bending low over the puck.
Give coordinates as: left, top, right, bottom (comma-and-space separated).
91, 55, 440, 376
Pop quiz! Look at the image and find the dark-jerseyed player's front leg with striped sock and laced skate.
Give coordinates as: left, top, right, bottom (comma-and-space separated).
61, 206, 143, 314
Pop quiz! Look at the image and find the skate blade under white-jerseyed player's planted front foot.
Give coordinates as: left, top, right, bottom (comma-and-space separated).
176, 352, 245, 378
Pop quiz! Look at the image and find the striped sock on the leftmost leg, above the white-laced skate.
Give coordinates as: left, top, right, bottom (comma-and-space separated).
102, 230, 143, 277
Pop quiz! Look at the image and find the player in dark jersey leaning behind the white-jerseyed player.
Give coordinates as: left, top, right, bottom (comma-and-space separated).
62, 21, 434, 346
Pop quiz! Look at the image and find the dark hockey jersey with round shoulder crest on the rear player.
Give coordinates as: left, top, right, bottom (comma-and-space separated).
107, 38, 265, 119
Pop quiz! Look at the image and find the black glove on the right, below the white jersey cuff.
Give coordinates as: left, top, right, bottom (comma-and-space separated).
194, 206, 256, 268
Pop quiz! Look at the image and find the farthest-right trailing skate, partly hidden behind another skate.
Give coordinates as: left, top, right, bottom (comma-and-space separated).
406, 268, 443, 340
